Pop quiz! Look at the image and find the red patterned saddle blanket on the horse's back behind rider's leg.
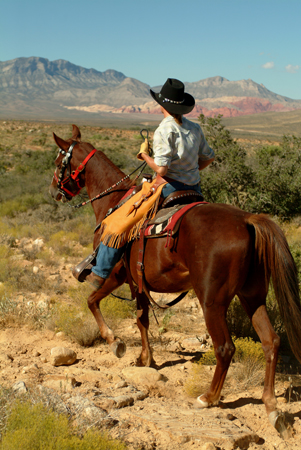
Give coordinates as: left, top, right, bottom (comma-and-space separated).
144, 202, 208, 243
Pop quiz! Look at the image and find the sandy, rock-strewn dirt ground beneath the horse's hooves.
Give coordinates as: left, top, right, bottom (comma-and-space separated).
0, 237, 301, 450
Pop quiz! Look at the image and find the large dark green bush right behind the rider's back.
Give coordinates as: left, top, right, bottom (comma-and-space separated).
199, 114, 301, 219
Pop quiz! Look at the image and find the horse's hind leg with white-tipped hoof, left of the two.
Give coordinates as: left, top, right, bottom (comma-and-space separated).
197, 301, 235, 408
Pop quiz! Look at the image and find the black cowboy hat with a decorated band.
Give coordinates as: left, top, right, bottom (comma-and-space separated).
150, 78, 195, 114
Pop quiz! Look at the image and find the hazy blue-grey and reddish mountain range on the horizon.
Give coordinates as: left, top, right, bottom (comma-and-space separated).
0, 57, 301, 118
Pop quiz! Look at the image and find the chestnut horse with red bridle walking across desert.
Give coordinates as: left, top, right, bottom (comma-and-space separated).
50, 125, 301, 428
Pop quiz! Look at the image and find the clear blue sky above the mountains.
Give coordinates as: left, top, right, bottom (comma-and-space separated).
0, 0, 301, 99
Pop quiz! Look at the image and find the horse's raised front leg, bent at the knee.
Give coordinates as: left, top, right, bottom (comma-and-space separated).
87, 262, 126, 358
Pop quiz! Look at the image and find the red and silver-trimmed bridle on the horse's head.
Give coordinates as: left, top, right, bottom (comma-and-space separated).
54, 142, 97, 197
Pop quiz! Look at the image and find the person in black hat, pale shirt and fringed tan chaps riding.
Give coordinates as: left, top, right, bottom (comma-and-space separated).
77, 78, 214, 290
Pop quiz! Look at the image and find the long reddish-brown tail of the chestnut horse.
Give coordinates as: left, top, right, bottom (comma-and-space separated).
246, 214, 301, 362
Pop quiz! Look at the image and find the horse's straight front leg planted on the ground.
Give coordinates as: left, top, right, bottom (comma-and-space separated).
136, 292, 155, 367
